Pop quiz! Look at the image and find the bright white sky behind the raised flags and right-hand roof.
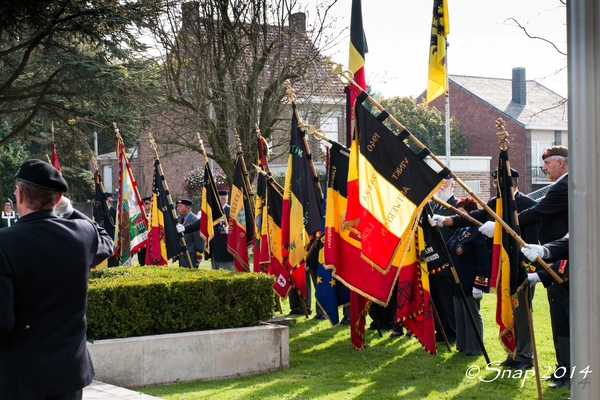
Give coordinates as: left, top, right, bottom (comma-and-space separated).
300, 0, 567, 97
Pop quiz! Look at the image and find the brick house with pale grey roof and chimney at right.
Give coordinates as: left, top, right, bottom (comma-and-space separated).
418, 68, 568, 193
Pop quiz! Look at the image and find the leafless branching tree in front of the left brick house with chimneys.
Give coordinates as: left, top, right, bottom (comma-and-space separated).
143, 0, 343, 182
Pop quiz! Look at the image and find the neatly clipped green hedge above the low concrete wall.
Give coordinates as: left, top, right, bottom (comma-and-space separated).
87, 267, 274, 340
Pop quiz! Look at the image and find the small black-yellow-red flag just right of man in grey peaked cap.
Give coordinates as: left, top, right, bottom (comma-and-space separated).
200, 161, 227, 253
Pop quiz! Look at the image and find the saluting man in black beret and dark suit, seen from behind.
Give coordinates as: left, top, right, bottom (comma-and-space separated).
0, 160, 113, 400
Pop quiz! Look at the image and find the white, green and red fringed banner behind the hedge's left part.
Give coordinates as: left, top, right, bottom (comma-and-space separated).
115, 139, 148, 266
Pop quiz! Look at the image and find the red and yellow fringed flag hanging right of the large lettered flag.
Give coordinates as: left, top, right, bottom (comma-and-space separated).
396, 221, 437, 354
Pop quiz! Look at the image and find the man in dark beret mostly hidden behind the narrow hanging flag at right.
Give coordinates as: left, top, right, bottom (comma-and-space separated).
429, 168, 538, 370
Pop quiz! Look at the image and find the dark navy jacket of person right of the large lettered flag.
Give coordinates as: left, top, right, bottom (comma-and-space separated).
446, 226, 490, 297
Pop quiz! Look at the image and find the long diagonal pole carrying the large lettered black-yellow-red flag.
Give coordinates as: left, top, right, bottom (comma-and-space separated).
330, 62, 569, 293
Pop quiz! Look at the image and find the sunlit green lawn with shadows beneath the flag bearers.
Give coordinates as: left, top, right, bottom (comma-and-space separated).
137, 282, 569, 400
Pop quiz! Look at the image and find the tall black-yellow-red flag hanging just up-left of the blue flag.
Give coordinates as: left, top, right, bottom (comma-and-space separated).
281, 104, 323, 272
